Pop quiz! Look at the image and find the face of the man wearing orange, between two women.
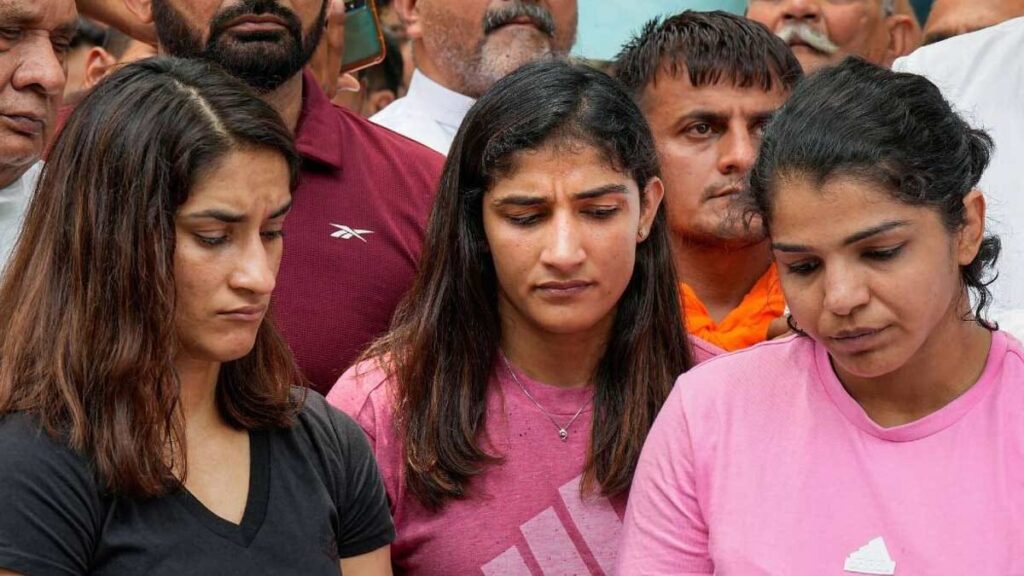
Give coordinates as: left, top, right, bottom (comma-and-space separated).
640, 69, 788, 249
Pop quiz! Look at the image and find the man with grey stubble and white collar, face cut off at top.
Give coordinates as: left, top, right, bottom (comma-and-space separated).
371, 0, 577, 154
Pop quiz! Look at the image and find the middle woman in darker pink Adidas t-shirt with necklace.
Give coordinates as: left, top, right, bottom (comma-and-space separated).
328, 61, 707, 575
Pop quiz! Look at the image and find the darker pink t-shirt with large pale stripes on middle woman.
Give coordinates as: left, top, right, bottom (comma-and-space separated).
328, 342, 716, 576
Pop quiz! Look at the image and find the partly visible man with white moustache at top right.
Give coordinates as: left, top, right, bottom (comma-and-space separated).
746, 0, 915, 74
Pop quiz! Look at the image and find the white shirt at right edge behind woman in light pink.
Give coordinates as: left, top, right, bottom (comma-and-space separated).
893, 17, 1024, 336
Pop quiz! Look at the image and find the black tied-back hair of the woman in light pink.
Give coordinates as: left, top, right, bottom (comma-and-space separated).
751, 57, 1000, 329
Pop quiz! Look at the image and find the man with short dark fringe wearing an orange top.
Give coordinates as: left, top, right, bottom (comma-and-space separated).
614, 11, 802, 351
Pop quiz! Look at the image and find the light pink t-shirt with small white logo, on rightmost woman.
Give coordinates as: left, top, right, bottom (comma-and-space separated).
618, 332, 1024, 576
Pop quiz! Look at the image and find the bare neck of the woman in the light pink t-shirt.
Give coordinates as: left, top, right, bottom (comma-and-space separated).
834, 296, 992, 427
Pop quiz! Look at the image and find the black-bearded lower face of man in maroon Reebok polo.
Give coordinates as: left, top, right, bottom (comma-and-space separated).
153, 0, 329, 92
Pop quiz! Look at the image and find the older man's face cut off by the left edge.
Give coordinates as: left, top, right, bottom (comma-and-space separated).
0, 0, 77, 181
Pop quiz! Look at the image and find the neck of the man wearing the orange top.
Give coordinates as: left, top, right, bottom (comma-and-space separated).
672, 236, 771, 322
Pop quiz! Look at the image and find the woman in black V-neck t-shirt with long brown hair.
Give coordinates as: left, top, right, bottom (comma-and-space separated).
0, 58, 393, 576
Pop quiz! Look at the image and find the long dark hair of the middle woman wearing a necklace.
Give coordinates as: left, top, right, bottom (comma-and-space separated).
369, 60, 692, 508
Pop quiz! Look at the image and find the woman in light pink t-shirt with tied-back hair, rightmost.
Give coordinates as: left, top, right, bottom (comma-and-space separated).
618, 59, 1024, 576
